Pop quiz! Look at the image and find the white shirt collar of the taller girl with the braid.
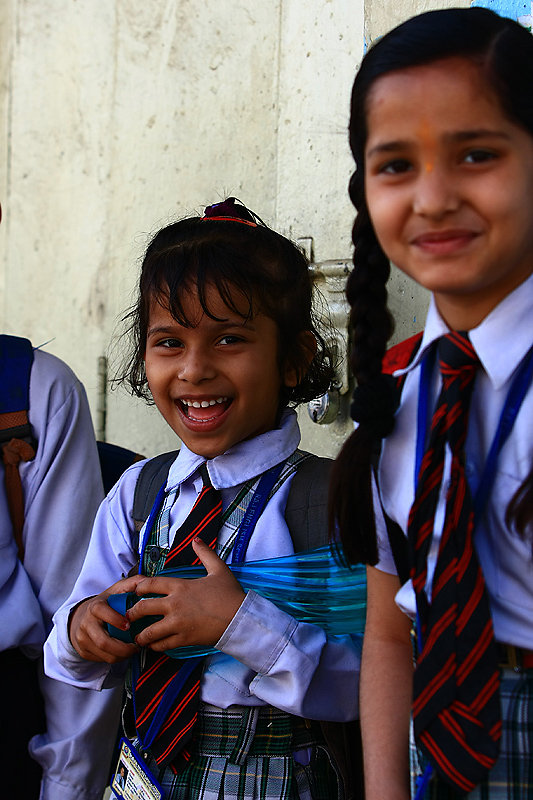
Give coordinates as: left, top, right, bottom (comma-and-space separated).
394, 274, 533, 390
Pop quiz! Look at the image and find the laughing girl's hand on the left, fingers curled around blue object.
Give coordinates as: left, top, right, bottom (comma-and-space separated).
68, 575, 145, 664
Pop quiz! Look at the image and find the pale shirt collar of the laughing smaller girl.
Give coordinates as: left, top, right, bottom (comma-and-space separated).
166, 408, 300, 491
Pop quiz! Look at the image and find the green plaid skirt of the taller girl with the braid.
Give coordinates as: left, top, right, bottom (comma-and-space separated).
411, 669, 533, 800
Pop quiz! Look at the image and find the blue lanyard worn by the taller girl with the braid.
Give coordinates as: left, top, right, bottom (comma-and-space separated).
415, 340, 533, 800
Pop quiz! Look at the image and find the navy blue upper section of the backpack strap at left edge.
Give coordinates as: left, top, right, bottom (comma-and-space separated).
0, 334, 33, 414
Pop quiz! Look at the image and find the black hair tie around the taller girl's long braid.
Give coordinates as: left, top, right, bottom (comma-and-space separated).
350, 373, 400, 439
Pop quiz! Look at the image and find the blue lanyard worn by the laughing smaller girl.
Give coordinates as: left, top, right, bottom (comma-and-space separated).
131, 461, 285, 749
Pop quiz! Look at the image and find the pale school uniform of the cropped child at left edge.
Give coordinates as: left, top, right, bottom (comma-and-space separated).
0, 350, 120, 800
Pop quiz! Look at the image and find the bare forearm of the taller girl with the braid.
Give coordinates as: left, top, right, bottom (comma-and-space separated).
360, 567, 413, 800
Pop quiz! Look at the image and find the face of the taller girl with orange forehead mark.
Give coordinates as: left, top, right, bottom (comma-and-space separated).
365, 57, 533, 329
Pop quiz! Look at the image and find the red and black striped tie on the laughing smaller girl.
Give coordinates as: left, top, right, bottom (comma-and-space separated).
135, 464, 222, 766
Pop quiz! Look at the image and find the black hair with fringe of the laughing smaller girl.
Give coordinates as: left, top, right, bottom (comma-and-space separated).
117, 198, 334, 408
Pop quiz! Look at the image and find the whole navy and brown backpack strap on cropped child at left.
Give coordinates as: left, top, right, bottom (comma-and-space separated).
0, 334, 37, 561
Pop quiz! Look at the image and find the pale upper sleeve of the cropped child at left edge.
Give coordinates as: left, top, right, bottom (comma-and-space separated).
20, 351, 104, 631
